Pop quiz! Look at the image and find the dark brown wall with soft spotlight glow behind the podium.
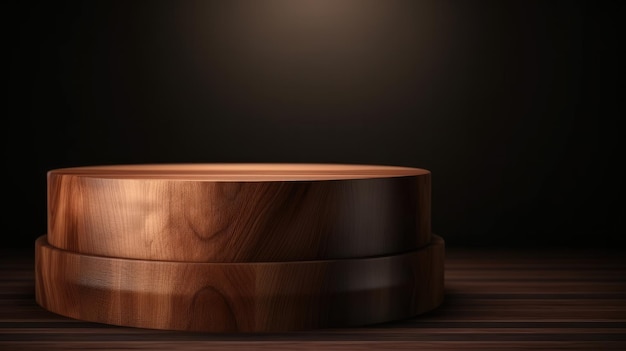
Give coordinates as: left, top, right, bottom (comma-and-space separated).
2, 0, 626, 252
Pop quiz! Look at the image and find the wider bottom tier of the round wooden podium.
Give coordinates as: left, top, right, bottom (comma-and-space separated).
35, 236, 445, 332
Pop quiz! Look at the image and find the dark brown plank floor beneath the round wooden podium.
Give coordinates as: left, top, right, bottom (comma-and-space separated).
0, 248, 626, 351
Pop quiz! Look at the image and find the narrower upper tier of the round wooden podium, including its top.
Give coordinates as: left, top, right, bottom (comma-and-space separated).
48, 164, 431, 262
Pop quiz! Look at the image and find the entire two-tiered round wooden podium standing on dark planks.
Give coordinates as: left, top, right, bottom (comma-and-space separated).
35, 164, 444, 333
